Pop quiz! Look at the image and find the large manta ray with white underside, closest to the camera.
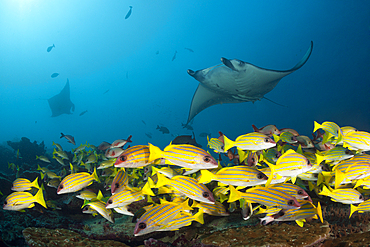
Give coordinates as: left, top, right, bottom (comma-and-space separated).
187, 41, 313, 123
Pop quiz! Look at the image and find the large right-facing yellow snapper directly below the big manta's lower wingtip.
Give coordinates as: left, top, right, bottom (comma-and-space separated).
149, 143, 218, 169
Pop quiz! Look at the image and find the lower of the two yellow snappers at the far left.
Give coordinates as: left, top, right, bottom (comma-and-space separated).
3, 189, 47, 211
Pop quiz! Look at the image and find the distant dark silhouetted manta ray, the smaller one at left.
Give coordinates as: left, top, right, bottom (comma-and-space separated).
48, 79, 75, 117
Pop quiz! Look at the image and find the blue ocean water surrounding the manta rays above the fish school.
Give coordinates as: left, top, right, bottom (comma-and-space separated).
0, 0, 370, 150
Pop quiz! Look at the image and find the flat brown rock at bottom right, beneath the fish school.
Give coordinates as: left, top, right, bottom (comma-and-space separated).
202, 221, 330, 247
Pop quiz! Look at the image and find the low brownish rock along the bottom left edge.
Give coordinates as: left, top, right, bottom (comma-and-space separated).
23, 227, 128, 247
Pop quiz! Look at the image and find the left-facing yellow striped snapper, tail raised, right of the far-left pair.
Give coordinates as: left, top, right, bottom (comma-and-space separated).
57, 168, 100, 195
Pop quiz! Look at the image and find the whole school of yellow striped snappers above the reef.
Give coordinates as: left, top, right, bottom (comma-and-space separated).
4, 122, 370, 236
